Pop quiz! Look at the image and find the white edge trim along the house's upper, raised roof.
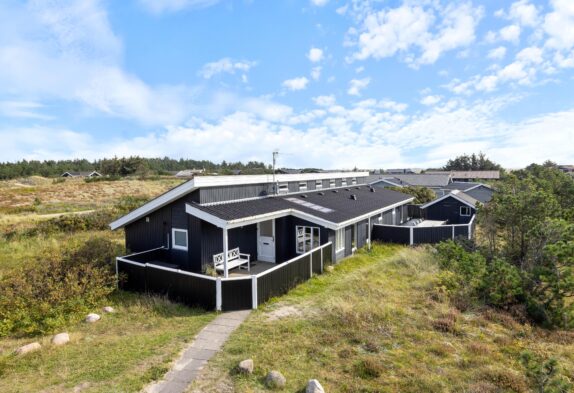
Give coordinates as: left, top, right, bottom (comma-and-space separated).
110, 172, 369, 231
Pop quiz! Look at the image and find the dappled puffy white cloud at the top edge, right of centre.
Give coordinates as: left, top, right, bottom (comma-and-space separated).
347, 2, 483, 66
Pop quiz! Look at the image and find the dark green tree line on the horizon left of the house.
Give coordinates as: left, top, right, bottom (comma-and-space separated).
0, 156, 271, 179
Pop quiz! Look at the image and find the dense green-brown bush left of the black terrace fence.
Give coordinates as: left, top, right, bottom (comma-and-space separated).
0, 238, 119, 337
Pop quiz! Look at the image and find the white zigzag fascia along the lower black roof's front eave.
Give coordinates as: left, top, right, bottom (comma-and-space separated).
185, 197, 415, 230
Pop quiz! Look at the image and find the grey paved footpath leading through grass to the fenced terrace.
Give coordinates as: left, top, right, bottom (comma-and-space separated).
144, 310, 251, 393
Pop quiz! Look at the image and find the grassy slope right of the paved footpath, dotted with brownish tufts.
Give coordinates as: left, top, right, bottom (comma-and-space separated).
194, 246, 574, 392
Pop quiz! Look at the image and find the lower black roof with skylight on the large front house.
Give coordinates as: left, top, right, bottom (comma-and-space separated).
191, 185, 412, 223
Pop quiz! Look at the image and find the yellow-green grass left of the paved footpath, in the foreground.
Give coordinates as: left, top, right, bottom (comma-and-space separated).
0, 293, 215, 393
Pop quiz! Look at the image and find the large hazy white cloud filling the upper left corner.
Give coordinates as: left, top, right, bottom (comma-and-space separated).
0, 0, 195, 125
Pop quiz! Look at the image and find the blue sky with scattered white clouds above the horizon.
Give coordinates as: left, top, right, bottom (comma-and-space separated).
0, 0, 574, 169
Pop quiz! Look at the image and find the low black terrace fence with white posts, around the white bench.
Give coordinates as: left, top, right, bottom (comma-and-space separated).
116, 242, 333, 311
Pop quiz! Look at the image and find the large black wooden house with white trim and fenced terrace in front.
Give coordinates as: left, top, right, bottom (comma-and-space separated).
110, 172, 414, 310
